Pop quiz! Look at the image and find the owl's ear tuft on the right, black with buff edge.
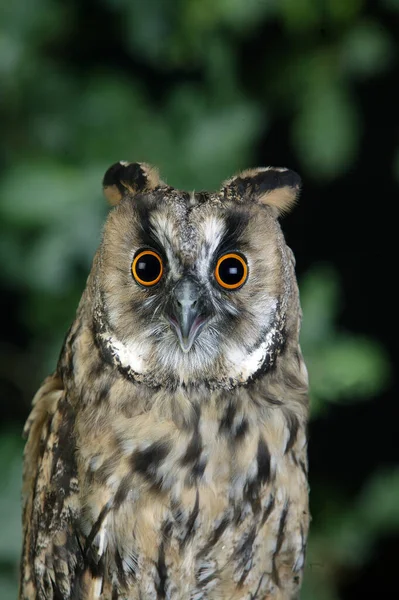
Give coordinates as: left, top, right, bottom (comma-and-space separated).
223, 167, 301, 216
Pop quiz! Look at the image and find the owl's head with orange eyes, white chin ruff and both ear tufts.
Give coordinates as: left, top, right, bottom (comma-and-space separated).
92, 162, 300, 388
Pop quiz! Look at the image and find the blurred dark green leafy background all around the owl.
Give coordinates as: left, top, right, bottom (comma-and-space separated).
0, 0, 399, 600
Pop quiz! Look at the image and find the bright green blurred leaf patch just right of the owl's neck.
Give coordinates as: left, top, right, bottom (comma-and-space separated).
300, 266, 390, 418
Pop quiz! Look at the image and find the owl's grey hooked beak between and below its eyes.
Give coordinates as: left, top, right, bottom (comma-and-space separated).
168, 277, 211, 353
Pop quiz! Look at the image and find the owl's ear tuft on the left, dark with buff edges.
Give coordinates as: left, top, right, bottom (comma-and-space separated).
103, 160, 162, 206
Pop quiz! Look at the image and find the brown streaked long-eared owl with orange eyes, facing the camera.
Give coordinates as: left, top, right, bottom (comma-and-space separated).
19, 162, 309, 600
